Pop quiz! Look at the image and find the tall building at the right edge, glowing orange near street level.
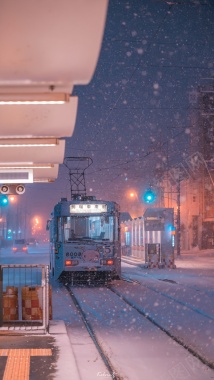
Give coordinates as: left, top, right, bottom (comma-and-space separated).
160, 85, 214, 250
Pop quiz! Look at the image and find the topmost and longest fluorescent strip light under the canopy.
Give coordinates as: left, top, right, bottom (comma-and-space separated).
0, 92, 70, 105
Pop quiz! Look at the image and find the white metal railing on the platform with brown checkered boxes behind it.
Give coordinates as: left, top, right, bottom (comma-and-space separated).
0, 264, 52, 334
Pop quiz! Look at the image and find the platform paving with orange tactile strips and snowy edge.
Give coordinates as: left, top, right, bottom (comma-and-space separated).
0, 320, 79, 380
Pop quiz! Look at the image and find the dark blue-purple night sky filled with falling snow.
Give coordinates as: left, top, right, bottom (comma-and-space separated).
20, 0, 214, 227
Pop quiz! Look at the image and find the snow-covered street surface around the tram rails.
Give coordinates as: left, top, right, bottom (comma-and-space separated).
1, 245, 214, 380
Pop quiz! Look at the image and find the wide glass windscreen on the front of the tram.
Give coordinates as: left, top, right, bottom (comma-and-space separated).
63, 216, 114, 242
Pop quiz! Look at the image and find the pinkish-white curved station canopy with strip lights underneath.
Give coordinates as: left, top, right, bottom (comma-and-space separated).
0, 0, 108, 183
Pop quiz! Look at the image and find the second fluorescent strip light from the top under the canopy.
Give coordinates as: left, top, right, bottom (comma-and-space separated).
0, 138, 59, 148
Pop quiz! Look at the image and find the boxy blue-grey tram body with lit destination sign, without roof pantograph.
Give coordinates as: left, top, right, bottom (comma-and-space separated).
48, 195, 121, 282
